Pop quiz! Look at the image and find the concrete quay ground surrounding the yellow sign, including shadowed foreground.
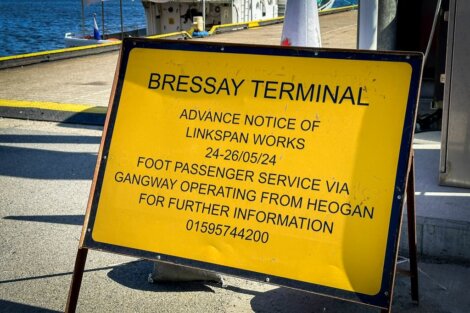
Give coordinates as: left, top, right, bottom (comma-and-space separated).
0, 11, 470, 313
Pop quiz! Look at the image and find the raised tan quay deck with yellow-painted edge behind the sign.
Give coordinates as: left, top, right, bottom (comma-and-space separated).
0, 11, 357, 113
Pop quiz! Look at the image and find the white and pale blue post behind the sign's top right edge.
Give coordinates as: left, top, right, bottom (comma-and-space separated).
357, 0, 378, 50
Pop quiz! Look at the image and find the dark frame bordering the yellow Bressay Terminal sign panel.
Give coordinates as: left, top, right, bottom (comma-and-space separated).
65, 38, 422, 309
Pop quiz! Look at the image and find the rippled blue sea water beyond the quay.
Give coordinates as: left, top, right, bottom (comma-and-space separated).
0, 0, 357, 57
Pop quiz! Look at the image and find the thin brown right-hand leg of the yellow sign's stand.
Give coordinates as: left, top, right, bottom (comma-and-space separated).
406, 152, 419, 303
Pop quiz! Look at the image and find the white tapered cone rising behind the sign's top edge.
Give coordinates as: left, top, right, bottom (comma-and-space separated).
281, 0, 321, 48
